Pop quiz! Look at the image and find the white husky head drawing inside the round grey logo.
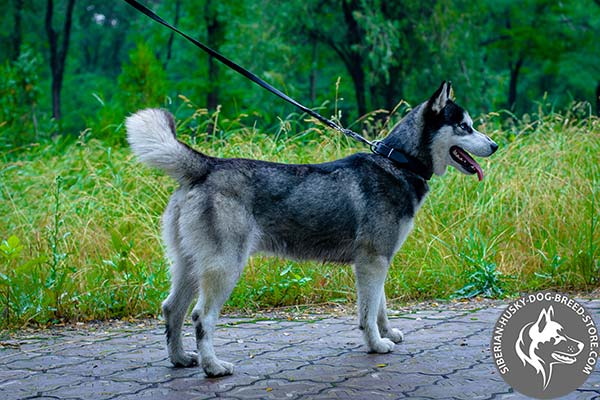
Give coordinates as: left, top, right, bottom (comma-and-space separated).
515, 306, 583, 390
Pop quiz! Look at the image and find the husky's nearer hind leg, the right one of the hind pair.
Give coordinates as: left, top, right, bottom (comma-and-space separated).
192, 255, 246, 377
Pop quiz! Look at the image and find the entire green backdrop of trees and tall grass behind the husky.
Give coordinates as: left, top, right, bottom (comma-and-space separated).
0, 0, 600, 324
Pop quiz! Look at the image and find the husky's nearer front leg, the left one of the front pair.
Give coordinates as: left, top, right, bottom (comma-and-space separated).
354, 256, 394, 353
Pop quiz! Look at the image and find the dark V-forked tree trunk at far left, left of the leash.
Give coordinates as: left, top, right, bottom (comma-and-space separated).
46, 0, 75, 119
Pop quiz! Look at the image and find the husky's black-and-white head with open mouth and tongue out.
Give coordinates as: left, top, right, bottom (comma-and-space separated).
384, 81, 498, 180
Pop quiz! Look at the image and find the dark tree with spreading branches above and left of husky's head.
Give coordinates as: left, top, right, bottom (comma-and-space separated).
303, 0, 432, 116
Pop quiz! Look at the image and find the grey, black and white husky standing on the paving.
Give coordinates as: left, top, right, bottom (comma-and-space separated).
126, 82, 498, 377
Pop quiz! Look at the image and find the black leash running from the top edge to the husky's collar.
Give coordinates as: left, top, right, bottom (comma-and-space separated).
124, 0, 432, 180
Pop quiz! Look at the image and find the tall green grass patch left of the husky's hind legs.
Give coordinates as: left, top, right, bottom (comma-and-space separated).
0, 136, 170, 326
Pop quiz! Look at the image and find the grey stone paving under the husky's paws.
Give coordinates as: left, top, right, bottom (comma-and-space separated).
0, 300, 600, 400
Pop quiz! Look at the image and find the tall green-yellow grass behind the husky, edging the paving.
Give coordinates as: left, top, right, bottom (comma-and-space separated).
0, 107, 600, 326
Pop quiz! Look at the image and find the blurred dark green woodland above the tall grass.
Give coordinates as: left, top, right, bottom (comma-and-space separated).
0, 0, 600, 145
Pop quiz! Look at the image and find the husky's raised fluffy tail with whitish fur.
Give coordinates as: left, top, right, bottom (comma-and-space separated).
125, 108, 210, 184
